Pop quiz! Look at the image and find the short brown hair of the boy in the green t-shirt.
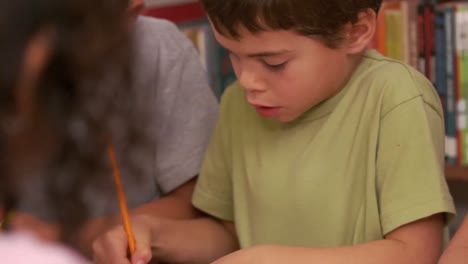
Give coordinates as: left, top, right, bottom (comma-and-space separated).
200, 0, 382, 47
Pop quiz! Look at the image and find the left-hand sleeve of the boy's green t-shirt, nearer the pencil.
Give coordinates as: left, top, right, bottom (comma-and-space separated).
192, 88, 234, 221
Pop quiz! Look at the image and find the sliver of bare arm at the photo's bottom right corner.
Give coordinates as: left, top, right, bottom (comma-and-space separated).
439, 216, 468, 264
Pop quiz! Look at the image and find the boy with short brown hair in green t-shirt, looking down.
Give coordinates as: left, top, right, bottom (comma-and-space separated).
94, 0, 455, 264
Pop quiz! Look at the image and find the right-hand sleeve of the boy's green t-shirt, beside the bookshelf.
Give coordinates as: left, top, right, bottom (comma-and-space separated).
377, 96, 455, 234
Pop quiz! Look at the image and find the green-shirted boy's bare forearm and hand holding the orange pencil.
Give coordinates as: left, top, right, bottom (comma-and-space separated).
93, 215, 239, 264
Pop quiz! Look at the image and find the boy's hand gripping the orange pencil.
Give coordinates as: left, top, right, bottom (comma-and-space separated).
93, 215, 157, 264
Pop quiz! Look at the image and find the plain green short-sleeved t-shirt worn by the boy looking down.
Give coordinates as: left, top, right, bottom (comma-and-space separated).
193, 51, 455, 248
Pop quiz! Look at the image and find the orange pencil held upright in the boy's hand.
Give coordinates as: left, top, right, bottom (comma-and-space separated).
108, 143, 136, 255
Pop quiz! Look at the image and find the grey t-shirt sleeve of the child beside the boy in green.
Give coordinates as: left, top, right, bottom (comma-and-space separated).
155, 22, 218, 193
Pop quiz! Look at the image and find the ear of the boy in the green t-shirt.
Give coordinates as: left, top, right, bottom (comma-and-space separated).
347, 9, 377, 54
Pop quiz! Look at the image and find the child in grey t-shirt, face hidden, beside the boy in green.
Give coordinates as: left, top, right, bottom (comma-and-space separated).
7, 0, 218, 256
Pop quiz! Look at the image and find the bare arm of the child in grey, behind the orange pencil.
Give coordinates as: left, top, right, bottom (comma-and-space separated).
80, 177, 199, 257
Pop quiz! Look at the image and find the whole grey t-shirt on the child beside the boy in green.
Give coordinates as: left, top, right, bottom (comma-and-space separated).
103, 17, 218, 214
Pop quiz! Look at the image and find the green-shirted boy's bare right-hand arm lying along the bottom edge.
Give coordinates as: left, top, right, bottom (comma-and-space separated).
215, 214, 443, 264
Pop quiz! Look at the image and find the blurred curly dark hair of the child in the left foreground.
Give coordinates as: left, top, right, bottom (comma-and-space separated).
0, 0, 145, 244
